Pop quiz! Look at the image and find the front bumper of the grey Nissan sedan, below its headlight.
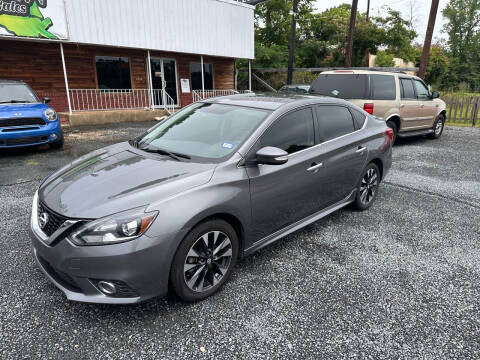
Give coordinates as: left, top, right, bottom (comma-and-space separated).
30, 227, 176, 304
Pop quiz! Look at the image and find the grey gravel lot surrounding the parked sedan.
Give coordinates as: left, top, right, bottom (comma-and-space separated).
0, 123, 480, 359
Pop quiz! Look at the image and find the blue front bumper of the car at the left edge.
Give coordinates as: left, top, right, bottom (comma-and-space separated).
0, 119, 62, 149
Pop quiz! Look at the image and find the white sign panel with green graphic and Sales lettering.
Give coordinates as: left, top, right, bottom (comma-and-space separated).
0, 0, 68, 39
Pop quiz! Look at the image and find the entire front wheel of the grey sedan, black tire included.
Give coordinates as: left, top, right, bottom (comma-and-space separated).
170, 219, 239, 302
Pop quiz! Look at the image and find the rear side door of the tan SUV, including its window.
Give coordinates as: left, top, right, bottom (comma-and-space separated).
399, 77, 421, 130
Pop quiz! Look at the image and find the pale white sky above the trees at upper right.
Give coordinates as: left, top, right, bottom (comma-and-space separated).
315, 0, 448, 43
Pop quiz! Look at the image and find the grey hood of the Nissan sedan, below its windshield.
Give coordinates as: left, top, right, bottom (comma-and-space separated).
39, 143, 215, 219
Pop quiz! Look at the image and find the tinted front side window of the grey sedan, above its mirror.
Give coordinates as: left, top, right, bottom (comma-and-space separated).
260, 108, 315, 154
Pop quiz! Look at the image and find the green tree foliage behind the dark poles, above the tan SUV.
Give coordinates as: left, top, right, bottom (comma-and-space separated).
255, 0, 416, 67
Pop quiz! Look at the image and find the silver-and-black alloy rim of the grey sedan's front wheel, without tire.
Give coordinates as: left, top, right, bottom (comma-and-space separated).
183, 231, 232, 292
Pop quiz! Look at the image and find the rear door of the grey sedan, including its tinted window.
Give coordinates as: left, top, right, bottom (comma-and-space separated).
315, 105, 368, 207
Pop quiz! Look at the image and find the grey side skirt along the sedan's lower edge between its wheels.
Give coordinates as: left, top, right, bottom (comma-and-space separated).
243, 189, 357, 256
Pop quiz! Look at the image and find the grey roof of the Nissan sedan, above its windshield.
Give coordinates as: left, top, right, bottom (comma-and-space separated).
202, 93, 350, 110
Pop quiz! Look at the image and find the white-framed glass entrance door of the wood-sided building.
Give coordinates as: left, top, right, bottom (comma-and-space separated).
150, 58, 178, 106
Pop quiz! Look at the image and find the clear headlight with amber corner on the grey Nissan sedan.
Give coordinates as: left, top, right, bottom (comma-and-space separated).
69, 208, 158, 245
